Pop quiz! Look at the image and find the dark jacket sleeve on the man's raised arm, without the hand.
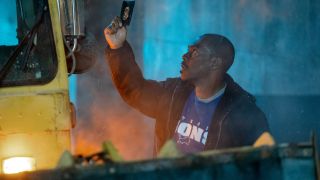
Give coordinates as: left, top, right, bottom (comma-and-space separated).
105, 42, 169, 118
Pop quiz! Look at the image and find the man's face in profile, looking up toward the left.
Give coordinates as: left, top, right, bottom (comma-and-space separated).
180, 39, 210, 81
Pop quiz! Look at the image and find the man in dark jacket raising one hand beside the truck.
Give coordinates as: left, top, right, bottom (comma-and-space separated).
104, 18, 274, 153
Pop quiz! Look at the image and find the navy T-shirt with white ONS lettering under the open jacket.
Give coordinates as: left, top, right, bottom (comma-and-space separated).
173, 88, 225, 153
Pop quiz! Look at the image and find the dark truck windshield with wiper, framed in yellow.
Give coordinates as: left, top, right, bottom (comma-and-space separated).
0, 0, 57, 87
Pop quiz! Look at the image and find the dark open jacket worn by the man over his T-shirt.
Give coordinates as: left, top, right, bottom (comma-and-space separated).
106, 42, 269, 153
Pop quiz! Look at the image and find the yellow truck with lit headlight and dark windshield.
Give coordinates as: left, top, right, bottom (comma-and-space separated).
0, 0, 90, 174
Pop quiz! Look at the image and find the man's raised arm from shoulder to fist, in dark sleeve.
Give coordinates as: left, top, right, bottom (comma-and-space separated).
104, 17, 168, 117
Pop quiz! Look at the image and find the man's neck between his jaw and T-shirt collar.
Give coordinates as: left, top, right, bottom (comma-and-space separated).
195, 76, 225, 99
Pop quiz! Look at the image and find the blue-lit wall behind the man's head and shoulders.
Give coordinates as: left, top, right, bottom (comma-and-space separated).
143, 0, 320, 142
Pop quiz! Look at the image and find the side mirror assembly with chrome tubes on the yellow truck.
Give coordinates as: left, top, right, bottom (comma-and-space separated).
57, 0, 96, 74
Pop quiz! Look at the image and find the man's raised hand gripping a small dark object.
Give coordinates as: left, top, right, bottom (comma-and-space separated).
104, 16, 127, 49
